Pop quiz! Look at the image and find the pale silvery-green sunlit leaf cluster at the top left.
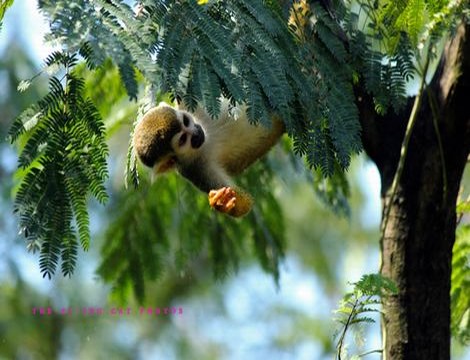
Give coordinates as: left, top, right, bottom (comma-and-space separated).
38, 0, 158, 99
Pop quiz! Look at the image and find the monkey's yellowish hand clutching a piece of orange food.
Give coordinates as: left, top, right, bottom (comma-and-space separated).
209, 187, 253, 217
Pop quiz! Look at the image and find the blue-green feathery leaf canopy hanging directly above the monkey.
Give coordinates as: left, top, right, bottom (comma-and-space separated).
36, 0, 361, 175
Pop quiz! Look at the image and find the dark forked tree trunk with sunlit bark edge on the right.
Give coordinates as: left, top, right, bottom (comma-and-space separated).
357, 26, 470, 360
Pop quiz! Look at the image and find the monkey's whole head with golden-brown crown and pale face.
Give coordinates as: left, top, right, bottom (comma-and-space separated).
134, 103, 205, 172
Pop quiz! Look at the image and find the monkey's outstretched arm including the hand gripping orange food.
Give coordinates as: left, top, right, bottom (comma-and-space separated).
179, 161, 253, 217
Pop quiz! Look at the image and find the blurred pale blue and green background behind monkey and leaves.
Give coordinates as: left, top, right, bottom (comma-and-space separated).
0, 0, 465, 359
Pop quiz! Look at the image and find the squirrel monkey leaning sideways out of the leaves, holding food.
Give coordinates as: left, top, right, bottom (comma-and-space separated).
133, 101, 285, 217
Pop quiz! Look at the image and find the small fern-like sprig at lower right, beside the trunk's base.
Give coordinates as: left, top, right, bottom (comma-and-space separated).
336, 274, 398, 360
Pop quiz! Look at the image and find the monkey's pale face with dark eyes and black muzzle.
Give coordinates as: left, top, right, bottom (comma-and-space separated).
171, 111, 205, 160
